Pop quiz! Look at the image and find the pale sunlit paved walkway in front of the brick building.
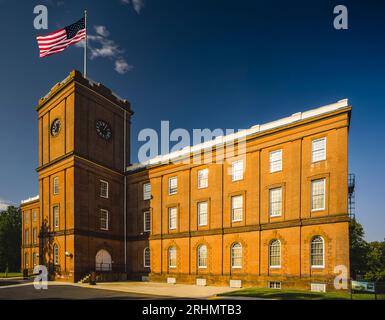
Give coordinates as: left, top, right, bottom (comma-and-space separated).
76, 281, 236, 299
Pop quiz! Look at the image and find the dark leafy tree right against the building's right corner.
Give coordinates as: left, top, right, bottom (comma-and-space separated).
349, 218, 369, 279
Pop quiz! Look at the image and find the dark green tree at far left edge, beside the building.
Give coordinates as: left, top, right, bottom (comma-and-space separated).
0, 206, 21, 271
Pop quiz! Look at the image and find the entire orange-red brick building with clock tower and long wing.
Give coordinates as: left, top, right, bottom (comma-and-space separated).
22, 71, 351, 288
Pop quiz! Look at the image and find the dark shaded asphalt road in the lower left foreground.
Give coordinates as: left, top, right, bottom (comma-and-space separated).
0, 284, 175, 300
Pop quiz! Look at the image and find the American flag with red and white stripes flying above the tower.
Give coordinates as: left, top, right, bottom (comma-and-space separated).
36, 17, 86, 58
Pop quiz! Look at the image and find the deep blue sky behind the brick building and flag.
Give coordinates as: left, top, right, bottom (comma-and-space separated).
0, 0, 385, 240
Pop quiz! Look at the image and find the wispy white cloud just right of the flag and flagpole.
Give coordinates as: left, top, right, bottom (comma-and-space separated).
76, 25, 133, 74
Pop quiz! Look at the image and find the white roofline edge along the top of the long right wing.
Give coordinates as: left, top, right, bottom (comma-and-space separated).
126, 99, 350, 172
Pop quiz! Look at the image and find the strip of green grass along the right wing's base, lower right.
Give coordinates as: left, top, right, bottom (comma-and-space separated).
221, 288, 385, 300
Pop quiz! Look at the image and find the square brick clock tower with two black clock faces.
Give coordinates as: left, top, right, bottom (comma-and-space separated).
37, 71, 132, 281
